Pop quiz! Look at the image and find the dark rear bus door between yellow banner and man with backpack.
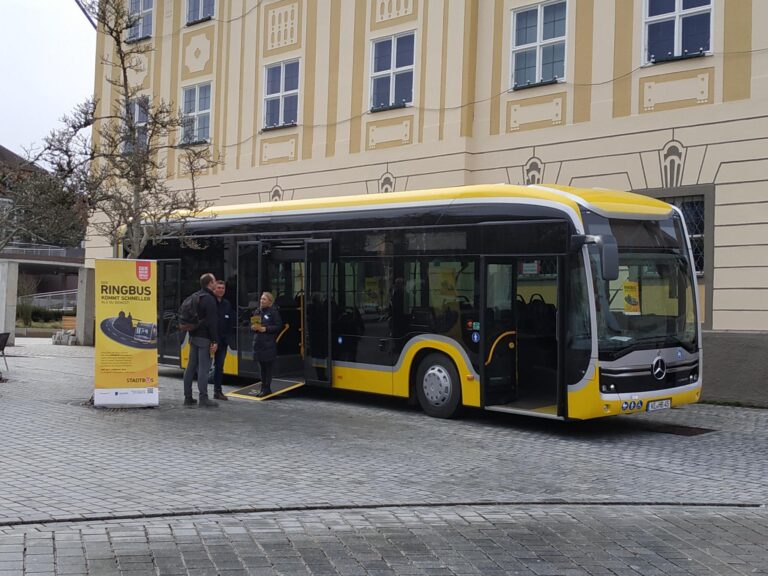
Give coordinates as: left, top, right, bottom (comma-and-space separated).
157, 260, 183, 365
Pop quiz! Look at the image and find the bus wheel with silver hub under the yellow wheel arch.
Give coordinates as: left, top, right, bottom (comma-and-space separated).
416, 354, 461, 418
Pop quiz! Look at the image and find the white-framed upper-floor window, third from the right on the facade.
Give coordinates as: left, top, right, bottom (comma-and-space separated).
371, 32, 415, 110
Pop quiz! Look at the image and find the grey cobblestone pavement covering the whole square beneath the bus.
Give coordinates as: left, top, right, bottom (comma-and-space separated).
0, 339, 768, 576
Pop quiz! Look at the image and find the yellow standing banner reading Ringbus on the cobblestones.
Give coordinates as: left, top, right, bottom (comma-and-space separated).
93, 259, 159, 406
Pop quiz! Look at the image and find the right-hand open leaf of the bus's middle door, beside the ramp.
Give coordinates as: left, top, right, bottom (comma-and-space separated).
304, 240, 333, 386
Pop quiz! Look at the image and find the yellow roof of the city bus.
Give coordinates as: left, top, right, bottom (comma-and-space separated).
197, 184, 672, 219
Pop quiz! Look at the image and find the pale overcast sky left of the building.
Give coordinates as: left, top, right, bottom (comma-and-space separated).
0, 0, 96, 155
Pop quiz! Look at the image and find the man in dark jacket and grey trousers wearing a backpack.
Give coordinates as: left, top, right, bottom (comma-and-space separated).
184, 273, 219, 408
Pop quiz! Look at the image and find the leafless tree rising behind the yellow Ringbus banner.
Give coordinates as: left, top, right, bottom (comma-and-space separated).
38, 0, 218, 258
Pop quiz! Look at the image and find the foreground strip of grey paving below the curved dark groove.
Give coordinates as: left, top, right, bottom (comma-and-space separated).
0, 505, 768, 576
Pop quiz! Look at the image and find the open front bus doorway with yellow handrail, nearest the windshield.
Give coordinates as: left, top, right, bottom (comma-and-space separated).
481, 255, 562, 416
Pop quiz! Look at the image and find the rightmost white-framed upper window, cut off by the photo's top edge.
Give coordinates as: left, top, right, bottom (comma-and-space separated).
645, 0, 712, 63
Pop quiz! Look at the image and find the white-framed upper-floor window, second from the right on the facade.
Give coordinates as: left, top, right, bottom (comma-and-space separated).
512, 2, 566, 88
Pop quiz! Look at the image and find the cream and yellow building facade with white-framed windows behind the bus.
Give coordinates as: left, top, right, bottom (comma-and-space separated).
88, 0, 768, 344
